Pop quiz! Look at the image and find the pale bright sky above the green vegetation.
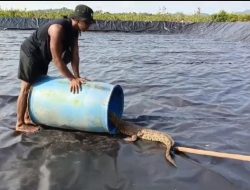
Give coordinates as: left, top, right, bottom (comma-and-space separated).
0, 1, 250, 14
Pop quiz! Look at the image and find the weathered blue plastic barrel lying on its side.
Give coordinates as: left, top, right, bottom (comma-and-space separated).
28, 76, 124, 134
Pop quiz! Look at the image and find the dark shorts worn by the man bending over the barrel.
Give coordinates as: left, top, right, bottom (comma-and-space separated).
18, 47, 48, 83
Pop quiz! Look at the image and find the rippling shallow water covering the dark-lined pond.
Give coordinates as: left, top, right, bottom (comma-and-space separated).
0, 31, 250, 190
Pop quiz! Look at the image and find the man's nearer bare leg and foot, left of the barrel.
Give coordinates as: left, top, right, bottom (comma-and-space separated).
16, 80, 39, 133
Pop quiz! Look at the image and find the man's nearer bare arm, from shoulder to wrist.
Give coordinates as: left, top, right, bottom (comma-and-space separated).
48, 24, 75, 81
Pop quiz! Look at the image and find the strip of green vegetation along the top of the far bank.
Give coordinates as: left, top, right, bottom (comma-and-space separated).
0, 8, 250, 22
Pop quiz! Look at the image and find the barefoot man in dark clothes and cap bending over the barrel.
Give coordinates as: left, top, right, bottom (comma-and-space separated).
16, 5, 94, 133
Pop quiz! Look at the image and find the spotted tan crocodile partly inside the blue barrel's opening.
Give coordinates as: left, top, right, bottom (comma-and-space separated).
109, 112, 177, 167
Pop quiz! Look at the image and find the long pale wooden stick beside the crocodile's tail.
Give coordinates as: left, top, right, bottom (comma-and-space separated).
174, 147, 250, 162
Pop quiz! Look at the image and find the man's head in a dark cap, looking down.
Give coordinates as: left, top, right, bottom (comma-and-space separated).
71, 5, 95, 32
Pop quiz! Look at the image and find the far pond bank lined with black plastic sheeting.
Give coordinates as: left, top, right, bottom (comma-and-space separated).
0, 18, 250, 42
